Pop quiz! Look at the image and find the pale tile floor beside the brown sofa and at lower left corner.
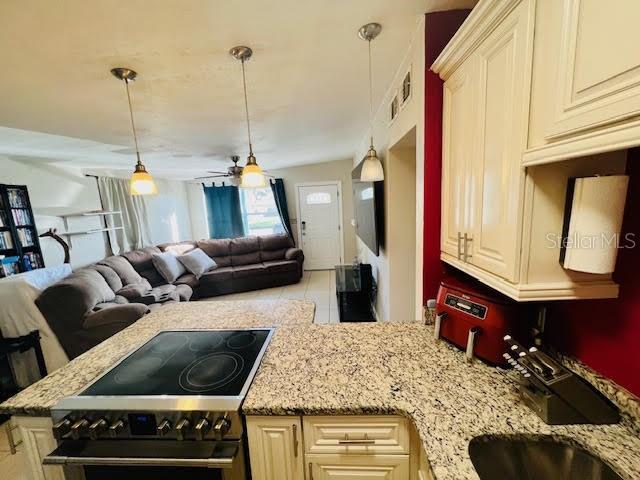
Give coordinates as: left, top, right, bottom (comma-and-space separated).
0, 270, 340, 480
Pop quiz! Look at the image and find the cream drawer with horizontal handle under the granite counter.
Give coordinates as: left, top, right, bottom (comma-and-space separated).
303, 416, 409, 455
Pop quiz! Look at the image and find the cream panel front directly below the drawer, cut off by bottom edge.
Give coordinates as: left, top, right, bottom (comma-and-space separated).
307, 455, 409, 480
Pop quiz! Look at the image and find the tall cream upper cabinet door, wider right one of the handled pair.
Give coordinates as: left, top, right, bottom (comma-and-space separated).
467, 0, 534, 281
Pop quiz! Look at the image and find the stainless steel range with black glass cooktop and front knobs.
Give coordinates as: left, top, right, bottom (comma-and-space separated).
43, 329, 273, 480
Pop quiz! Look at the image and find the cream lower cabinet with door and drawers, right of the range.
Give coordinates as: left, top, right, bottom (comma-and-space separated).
247, 415, 432, 480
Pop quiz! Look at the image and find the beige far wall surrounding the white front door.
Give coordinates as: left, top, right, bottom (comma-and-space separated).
269, 158, 357, 263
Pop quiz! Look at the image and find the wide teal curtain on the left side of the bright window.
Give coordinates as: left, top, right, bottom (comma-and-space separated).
203, 184, 245, 238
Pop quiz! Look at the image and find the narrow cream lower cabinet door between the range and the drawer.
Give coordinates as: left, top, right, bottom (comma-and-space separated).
247, 417, 304, 480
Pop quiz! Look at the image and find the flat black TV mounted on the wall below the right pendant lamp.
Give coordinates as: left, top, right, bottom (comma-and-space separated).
351, 162, 384, 257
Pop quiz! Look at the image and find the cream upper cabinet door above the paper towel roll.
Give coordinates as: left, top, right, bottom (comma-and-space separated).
548, 0, 640, 138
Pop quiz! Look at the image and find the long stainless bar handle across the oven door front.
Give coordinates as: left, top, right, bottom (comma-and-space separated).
42, 455, 235, 468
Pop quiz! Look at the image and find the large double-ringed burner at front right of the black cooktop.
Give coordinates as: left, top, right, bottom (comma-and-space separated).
179, 352, 244, 393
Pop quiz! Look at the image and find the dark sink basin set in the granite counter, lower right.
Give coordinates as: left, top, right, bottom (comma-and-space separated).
469, 436, 623, 480
